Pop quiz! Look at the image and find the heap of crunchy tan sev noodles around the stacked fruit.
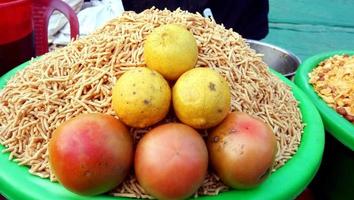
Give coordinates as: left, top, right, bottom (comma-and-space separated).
0, 8, 303, 198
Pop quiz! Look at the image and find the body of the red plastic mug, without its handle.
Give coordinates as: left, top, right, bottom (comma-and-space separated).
0, 0, 34, 75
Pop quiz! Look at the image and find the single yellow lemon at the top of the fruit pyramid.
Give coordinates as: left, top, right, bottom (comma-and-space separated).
144, 24, 198, 80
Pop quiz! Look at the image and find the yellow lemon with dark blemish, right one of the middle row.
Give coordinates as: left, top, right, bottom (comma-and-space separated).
172, 67, 231, 128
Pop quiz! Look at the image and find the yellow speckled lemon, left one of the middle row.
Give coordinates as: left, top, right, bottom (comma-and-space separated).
112, 67, 171, 128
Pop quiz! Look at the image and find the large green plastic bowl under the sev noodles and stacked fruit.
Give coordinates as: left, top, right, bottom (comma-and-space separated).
0, 63, 324, 200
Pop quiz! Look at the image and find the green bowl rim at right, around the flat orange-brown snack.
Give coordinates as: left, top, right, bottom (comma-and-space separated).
295, 51, 354, 151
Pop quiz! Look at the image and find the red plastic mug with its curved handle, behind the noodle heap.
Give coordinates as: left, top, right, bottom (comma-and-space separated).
0, 0, 79, 76
